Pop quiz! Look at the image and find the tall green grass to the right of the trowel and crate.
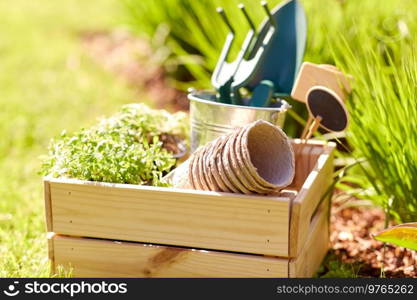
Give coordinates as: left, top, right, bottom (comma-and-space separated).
311, 0, 417, 222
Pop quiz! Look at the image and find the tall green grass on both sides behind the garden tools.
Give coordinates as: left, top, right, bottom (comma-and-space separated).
124, 0, 417, 222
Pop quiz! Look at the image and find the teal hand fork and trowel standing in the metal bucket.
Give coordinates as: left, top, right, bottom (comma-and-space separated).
211, 0, 306, 107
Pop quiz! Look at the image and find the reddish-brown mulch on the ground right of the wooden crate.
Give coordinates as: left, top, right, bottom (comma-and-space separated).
330, 203, 417, 277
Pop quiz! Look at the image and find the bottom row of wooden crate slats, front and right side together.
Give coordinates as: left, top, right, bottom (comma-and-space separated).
49, 195, 329, 278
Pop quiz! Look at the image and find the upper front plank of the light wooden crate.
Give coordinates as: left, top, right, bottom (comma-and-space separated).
51, 182, 294, 256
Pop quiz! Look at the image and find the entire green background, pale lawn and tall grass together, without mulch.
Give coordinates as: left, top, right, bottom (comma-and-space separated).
0, 0, 417, 277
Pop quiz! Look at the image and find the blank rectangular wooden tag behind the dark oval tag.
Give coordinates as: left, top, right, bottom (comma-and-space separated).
291, 62, 353, 102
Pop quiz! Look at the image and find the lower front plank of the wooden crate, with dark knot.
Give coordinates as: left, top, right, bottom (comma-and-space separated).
53, 236, 288, 277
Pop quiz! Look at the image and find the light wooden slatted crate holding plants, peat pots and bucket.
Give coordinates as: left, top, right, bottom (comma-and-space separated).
44, 141, 334, 277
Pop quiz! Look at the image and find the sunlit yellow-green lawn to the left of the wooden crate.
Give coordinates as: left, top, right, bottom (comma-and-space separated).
0, 0, 140, 277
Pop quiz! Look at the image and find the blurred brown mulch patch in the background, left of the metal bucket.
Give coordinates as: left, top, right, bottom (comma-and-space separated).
81, 30, 188, 111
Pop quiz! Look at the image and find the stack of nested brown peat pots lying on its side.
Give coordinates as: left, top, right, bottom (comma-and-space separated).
173, 120, 295, 194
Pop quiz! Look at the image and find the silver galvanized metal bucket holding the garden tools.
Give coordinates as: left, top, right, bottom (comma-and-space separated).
188, 91, 291, 152
